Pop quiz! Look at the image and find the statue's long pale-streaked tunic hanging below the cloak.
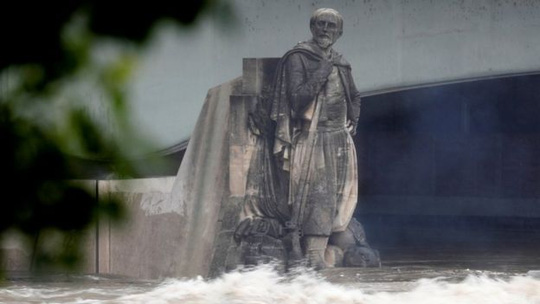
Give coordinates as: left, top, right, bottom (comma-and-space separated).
290, 67, 358, 235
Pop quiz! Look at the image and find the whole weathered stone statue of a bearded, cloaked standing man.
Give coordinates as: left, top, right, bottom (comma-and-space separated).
236, 8, 379, 269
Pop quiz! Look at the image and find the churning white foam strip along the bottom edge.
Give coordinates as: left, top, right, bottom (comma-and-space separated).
0, 266, 540, 304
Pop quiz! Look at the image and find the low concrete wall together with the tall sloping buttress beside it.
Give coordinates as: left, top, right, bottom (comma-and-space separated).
93, 79, 241, 278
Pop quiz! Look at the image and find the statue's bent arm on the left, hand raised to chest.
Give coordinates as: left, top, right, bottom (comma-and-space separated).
285, 53, 332, 116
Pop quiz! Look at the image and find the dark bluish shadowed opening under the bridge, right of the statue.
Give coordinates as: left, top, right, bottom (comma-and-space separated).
356, 74, 540, 253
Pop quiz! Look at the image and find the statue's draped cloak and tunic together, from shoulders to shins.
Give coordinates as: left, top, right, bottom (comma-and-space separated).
271, 43, 360, 236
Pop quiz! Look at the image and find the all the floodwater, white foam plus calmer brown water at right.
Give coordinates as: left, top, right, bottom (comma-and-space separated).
0, 252, 540, 304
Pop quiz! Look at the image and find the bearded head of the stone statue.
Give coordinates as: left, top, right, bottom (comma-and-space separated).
309, 8, 343, 49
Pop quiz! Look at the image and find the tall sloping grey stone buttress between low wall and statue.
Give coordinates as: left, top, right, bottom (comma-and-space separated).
172, 78, 241, 277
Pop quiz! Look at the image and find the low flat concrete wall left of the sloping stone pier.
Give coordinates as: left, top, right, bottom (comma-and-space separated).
96, 177, 179, 278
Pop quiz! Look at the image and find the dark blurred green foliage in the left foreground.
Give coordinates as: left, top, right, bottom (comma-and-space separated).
0, 0, 232, 269
